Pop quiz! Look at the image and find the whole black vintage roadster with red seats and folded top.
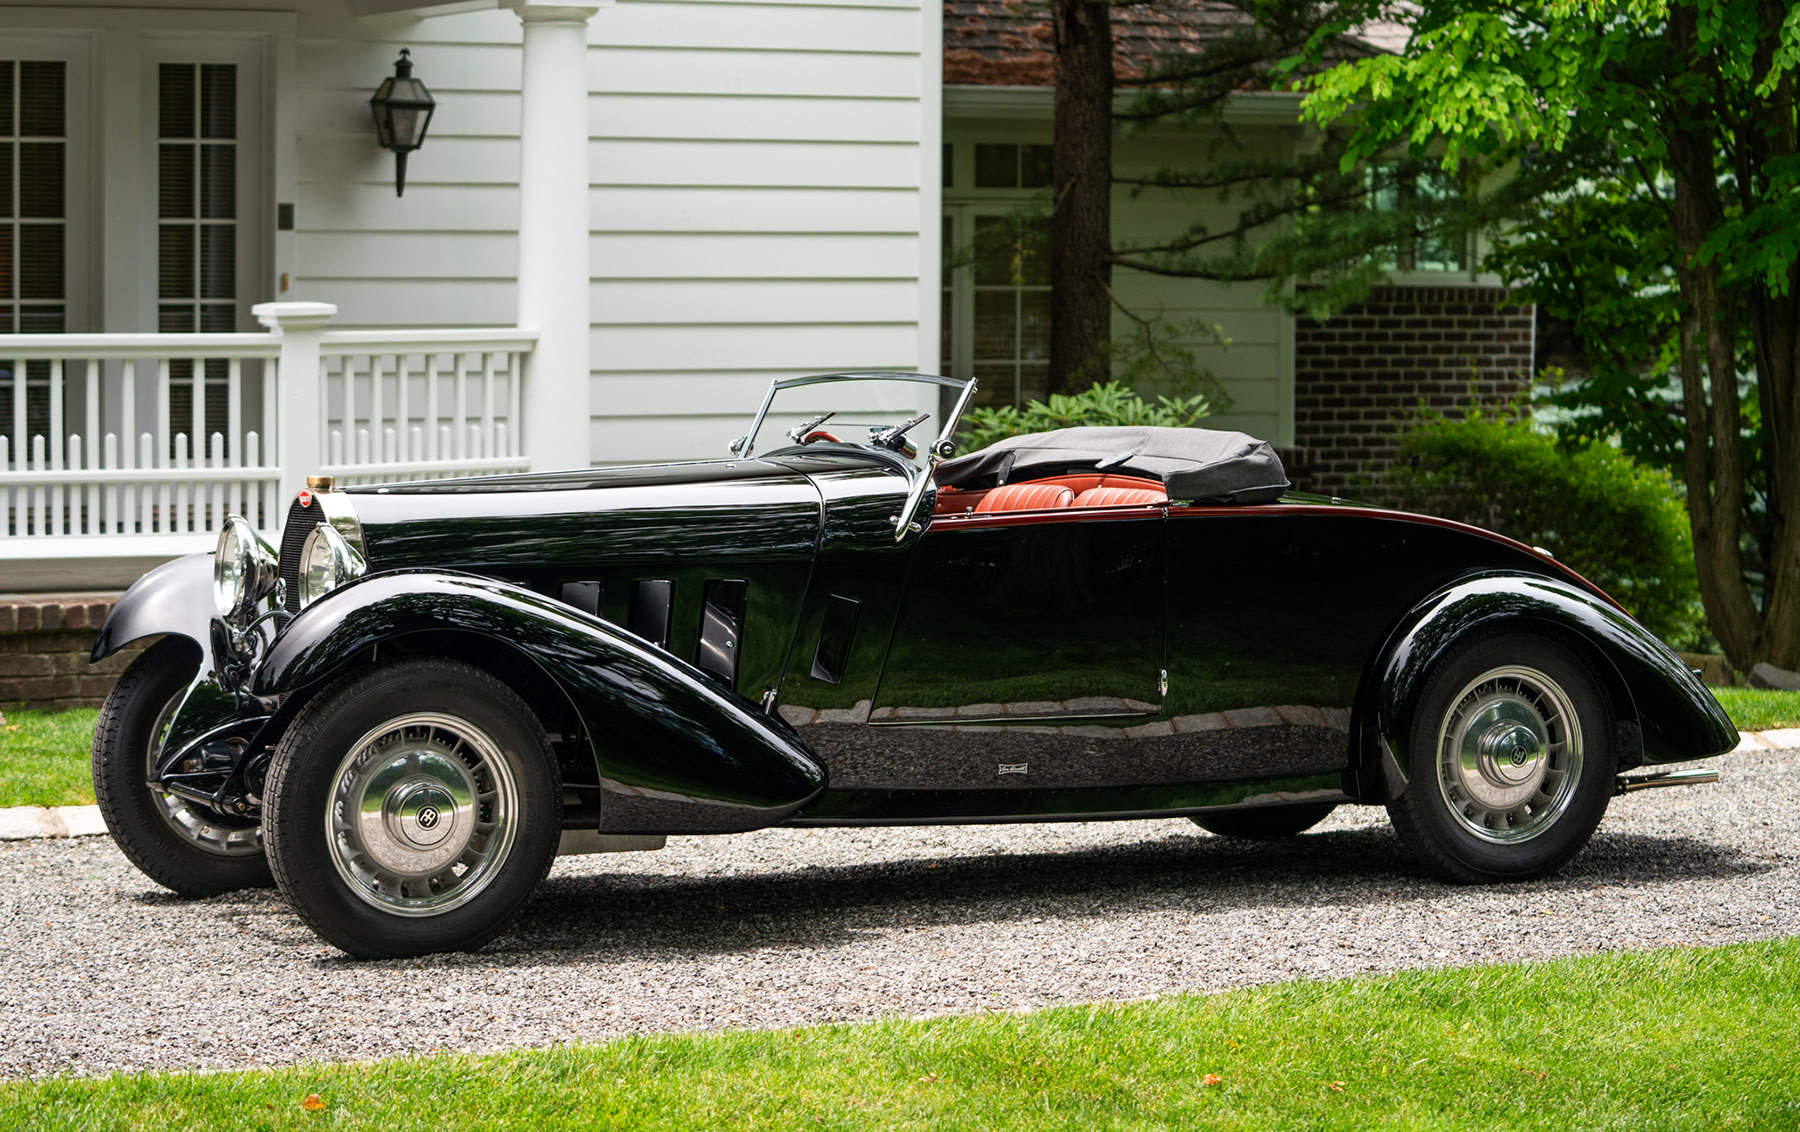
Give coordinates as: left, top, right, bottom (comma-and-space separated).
94, 374, 1737, 956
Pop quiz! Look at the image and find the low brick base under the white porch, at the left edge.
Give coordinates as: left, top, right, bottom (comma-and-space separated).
0, 594, 148, 711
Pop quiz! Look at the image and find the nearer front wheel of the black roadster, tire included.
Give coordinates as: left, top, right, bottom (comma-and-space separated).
263, 657, 562, 959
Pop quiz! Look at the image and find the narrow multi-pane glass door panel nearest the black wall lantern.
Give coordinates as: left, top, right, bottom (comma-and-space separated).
157, 63, 238, 454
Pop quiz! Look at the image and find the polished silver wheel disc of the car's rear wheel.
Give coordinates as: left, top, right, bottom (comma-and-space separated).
1438, 666, 1582, 844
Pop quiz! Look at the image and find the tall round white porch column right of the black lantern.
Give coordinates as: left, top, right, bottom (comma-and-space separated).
508, 0, 610, 472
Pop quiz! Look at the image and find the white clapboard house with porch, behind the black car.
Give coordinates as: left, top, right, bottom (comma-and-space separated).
0, 0, 1504, 592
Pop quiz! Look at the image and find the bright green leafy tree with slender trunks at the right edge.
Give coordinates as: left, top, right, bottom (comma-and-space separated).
1307, 0, 1800, 668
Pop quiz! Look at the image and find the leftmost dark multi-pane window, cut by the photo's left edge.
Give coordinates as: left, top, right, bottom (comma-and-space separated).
0, 59, 68, 455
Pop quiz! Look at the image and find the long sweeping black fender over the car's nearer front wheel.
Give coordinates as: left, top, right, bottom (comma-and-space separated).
252, 570, 824, 833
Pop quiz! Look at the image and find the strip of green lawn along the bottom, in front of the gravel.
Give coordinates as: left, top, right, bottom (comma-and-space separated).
0, 939, 1800, 1132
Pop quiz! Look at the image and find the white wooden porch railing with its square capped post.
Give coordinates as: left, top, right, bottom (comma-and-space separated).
0, 304, 536, 554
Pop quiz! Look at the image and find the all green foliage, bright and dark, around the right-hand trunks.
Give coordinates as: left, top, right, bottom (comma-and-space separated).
1303, 0, 1800, 668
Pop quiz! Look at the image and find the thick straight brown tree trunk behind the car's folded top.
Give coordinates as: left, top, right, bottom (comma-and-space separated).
1049, 0, 1112, 392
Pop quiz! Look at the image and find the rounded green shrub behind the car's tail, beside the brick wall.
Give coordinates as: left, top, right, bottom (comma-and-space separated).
1386, 412, 1705, 648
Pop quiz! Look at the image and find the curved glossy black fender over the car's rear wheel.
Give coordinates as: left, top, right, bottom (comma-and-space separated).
1345, 572, 1737, 801
